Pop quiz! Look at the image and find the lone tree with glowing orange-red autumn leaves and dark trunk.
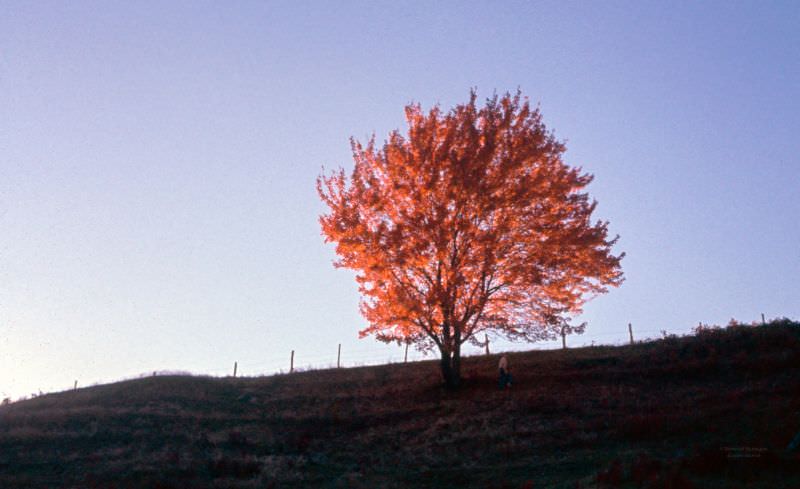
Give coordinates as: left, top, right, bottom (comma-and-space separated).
317, 91, 624, 387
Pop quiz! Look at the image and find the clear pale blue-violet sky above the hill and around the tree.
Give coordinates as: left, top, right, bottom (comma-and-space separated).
0, 1, 800, 397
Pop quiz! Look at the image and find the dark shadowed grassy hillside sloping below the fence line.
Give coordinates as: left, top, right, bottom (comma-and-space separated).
0, 320, 800, 489
